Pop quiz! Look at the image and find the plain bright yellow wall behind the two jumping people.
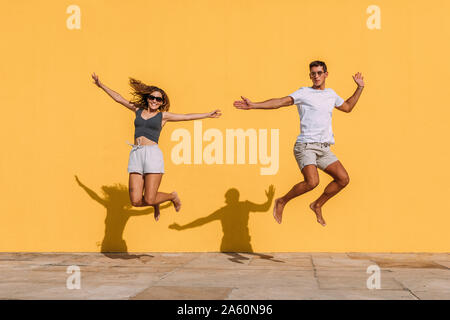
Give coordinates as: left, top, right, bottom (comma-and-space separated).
0, 0, 450, 252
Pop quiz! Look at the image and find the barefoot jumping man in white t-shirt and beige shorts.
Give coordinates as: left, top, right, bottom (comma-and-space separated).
234, 61, 364, 226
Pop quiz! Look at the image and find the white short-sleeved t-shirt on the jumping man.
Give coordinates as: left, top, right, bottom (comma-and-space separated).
289, 87, 344, 144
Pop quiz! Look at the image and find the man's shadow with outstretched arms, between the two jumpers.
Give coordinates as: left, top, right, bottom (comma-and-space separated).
169, 185, 283, 263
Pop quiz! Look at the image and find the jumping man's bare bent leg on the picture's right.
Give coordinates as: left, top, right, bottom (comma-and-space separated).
309, 160, 350, 226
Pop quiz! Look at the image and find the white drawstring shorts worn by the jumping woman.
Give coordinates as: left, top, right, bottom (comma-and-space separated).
128, 144, 164, 175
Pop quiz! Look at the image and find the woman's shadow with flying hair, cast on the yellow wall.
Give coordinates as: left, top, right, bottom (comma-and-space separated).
75, 176, 171, 259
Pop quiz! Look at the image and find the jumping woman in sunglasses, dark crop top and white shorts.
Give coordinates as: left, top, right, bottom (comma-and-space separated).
92, 73, 221, 221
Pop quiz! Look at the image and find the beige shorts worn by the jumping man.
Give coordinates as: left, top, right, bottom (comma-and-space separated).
294, 142, 338, 170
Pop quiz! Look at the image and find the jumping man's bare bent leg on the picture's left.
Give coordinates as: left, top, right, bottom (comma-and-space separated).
273, 164, 319, 223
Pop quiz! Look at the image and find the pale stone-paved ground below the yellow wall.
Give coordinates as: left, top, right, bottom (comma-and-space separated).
0, 253, 450, 300
